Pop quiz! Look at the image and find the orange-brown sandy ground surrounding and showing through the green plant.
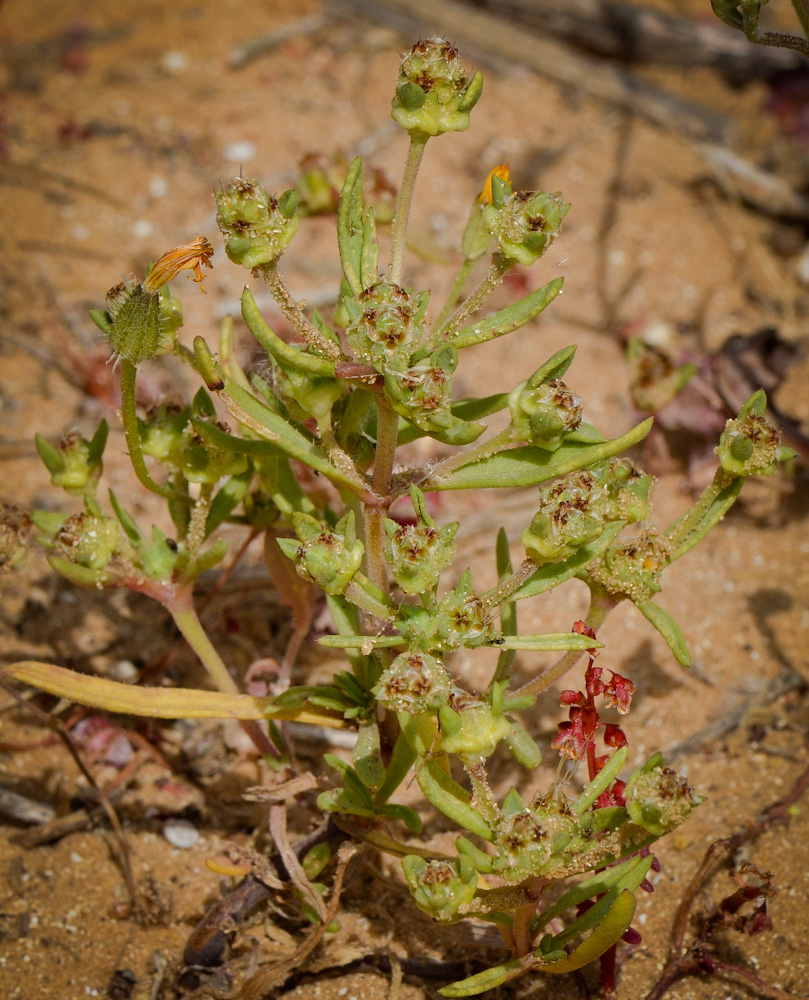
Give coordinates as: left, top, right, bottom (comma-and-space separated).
0, 0, 809, 1000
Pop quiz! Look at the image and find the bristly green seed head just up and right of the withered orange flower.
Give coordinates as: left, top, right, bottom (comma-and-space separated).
216, 177, 298, 270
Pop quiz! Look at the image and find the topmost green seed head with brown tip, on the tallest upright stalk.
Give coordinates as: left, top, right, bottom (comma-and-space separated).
391, 38, 483, 140
